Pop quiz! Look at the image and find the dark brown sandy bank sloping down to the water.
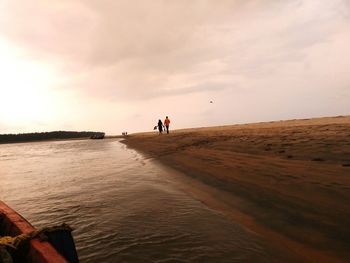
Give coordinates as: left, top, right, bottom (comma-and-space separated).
123, 116, 350, 262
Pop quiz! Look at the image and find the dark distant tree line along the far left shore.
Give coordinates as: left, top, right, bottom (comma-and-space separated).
0, 131, 105, 143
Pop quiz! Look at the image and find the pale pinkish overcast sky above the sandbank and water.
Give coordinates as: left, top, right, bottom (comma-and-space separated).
0, 0, 350, 134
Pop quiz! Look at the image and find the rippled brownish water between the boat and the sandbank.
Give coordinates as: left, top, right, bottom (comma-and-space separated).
0, 140, 278, 262
